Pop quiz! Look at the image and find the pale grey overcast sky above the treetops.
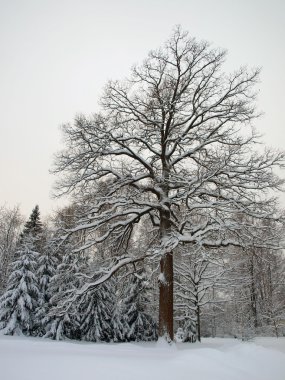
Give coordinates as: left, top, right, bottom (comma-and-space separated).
0, 0, 285, 215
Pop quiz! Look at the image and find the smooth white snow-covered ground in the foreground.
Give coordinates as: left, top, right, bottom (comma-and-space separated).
0, 335, 285, 380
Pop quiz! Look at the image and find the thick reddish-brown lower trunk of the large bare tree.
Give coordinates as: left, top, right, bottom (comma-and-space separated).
159, 252, 174, 341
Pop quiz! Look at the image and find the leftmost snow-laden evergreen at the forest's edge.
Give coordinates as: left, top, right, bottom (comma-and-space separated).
0, 235, 40, 335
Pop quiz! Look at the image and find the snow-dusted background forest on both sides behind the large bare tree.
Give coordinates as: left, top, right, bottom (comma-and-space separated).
0, 204, 285, 342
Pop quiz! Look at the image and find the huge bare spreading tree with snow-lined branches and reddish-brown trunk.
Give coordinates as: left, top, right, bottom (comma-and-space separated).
54, 28, 284, 339
